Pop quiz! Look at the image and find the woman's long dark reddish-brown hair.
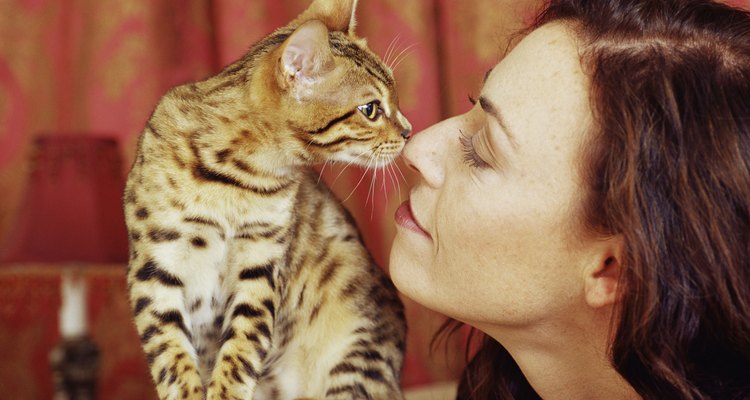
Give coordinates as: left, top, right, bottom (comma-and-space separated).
447, 0, 750, 400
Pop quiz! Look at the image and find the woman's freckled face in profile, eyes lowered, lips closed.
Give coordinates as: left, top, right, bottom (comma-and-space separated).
390, 24, 600, 328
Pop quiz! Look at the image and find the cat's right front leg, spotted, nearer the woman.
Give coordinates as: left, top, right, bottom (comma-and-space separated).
207, 262, 277, 400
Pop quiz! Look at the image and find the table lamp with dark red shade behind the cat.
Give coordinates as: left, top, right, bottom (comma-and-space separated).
0, 132, 128, 400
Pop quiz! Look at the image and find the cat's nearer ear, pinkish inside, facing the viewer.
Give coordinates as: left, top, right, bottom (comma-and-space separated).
279, 20, 335, 89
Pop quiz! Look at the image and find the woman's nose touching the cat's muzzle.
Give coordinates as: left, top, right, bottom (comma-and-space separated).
403, 121, 447, 187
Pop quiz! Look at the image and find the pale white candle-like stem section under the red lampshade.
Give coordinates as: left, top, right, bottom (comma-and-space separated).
60, 270, 86, 339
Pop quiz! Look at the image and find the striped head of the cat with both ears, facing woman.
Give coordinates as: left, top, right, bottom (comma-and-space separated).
258, 0, 411, 167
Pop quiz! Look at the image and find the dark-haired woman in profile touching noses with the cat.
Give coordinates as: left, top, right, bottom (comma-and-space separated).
390, 0, 750, 399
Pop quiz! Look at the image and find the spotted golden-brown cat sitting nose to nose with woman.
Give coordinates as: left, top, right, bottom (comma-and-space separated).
123, 0, 411, 399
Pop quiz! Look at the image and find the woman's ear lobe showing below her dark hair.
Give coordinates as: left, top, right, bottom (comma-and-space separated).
584, 235, 623, 308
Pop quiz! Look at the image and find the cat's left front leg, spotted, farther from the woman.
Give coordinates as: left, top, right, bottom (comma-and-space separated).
128, 256, 204, 400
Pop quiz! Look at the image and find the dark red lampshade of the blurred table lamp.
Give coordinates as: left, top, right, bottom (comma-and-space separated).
0, 133, 128, 263
